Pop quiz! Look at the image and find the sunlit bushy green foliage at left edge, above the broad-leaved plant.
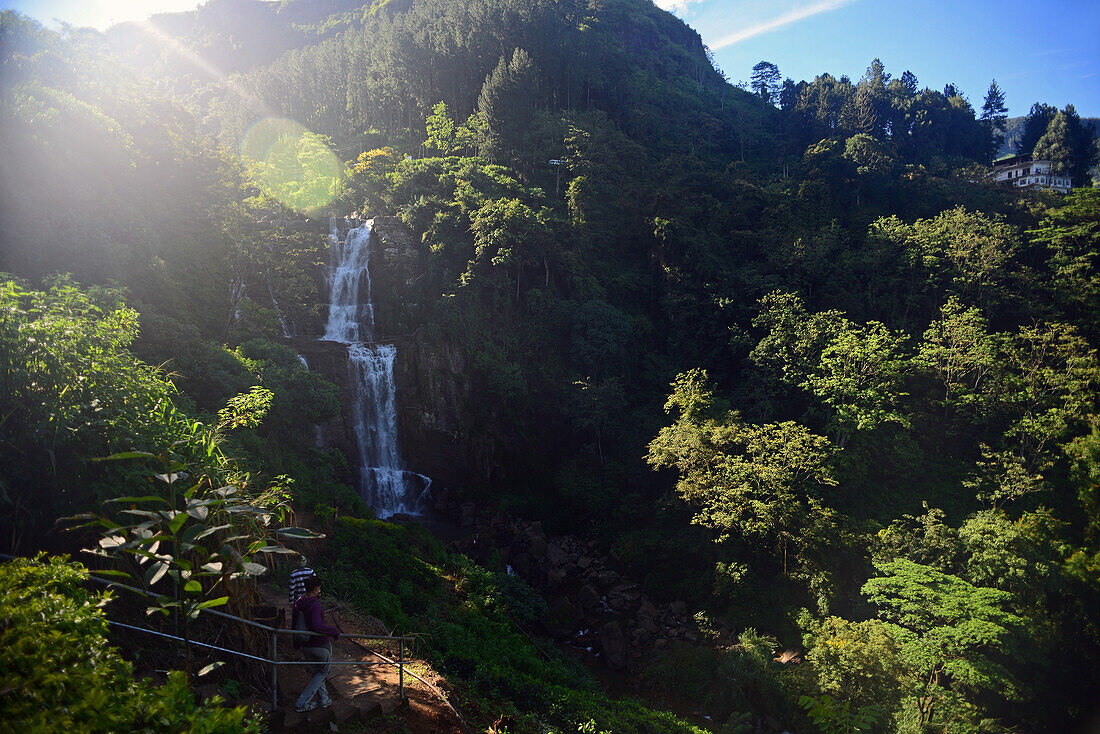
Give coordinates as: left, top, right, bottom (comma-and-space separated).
0, 276, 188, 548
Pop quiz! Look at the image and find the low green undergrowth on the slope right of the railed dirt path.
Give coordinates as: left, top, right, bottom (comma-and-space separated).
319, 517, 700, 734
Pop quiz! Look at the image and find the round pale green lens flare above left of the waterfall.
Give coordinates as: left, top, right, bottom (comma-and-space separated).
241, 118, 343, 213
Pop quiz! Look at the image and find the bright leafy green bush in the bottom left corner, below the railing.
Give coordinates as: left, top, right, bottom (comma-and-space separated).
0, 556, 262, 734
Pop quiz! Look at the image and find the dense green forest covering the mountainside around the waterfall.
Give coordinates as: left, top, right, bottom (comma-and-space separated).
0, 0, 1100, 734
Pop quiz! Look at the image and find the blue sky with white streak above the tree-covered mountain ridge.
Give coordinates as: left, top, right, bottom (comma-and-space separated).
8, 0, 1100, 117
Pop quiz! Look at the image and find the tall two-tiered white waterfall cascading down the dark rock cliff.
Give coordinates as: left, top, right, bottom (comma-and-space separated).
322, 220, 431, 517
